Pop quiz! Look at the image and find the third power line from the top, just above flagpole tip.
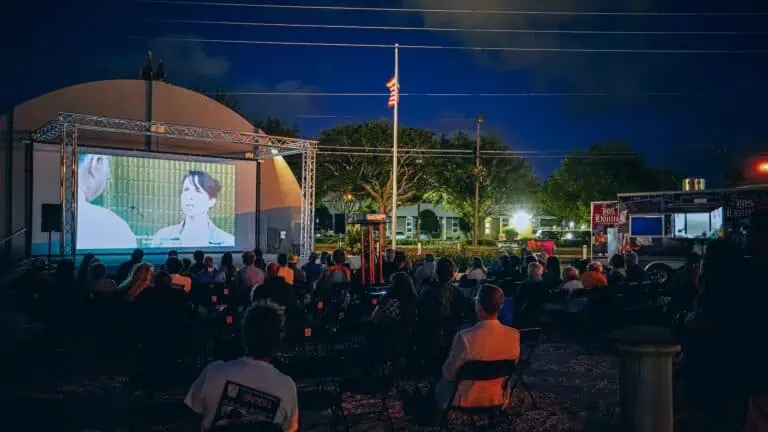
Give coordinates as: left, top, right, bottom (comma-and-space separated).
136, 36, 768, 54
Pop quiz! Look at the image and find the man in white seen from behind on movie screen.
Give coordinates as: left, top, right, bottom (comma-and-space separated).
76, 154, 136, 250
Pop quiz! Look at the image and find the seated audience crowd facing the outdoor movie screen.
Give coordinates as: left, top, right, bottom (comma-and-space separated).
6, 208, 768, 431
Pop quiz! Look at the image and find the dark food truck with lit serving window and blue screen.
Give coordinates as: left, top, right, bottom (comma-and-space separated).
593, 179, 768, 282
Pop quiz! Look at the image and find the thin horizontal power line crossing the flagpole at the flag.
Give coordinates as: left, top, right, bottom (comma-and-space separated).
217, 92, 682, 97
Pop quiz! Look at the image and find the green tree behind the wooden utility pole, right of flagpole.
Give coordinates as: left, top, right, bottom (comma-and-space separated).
427, 133, 536, 240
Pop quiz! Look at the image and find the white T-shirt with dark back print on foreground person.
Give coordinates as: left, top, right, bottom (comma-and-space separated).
184, 357, 299, 432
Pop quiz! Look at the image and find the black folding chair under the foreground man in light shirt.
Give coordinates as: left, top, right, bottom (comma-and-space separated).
440, 360, 517, 431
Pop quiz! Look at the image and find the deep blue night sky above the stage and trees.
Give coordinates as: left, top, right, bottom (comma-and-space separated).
0, 0, 768, 184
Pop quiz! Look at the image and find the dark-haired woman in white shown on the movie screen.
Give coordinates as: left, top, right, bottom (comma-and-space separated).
152, 171, 235, 248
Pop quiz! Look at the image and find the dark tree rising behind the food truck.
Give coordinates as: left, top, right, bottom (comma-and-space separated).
537, 143, 682, 223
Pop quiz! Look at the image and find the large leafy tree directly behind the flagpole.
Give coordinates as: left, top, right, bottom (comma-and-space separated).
317, 122, 437, 214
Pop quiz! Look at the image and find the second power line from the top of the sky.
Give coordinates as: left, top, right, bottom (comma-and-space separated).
159, 19, 768, 36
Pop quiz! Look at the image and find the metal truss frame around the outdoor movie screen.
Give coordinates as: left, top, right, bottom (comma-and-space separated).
32, 112, 317, 258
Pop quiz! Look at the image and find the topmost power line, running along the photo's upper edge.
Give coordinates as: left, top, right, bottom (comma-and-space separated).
137, 0, 768, 17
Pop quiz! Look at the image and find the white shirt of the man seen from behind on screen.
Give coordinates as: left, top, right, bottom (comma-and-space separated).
77, 192, 136, 250
